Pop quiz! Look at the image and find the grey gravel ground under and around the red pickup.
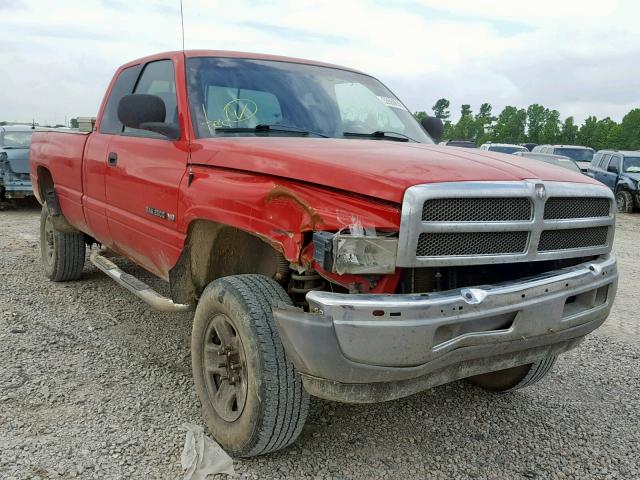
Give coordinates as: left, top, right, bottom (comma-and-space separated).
0, 203, 640, 480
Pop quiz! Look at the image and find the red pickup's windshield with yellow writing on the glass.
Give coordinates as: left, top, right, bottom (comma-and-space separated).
187, 57, 433, 143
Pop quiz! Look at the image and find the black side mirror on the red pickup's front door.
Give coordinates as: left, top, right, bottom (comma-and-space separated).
118, 93, 180, 140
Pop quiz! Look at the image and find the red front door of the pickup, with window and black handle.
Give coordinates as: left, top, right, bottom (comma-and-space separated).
104, 59, 188, 279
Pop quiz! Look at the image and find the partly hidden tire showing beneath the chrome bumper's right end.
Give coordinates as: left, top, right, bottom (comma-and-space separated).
467, 356, 556, 392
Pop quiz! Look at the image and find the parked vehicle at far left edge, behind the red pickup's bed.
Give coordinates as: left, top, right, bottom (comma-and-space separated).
0, 126, 33, 202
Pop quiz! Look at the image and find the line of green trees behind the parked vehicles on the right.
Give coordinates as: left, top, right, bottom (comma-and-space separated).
414, 98, 640, 150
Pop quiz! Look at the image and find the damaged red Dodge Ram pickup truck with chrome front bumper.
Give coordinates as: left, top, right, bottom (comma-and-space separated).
30, 51, 618, 456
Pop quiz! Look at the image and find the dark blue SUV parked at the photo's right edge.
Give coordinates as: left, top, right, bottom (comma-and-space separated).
588, 150, 640, 213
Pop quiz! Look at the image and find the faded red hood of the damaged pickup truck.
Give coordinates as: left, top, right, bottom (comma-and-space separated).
191, 137, 598, 203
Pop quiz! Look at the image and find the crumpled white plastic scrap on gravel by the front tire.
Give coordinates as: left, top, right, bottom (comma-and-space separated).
180, 425, 236, 480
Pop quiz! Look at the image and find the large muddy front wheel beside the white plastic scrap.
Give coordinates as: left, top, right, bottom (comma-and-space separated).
191, 275, 309, 457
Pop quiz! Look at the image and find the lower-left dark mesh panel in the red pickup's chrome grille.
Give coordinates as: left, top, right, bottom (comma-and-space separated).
416, 232, 529, 257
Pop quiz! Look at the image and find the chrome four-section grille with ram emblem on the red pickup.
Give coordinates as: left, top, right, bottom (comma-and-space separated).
397, 180, 615, 267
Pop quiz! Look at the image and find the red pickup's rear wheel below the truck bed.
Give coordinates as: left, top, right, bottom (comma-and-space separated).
40, 203, 86, 282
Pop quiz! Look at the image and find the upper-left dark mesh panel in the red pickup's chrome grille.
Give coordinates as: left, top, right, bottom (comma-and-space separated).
422, 198, 533, 222
